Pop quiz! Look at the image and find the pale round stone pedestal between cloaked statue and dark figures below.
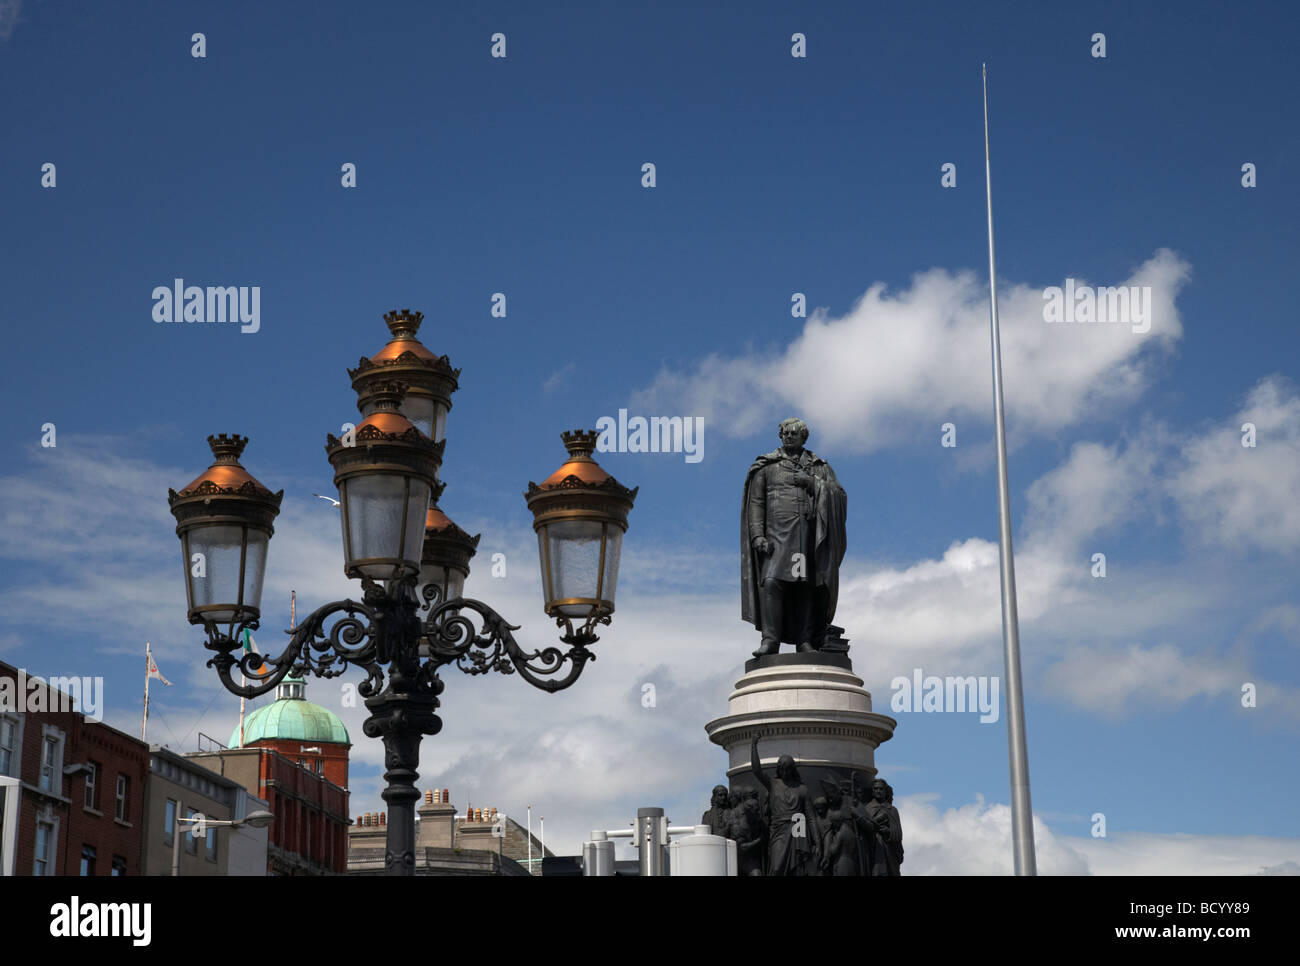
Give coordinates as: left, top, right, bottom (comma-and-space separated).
705, 651, 898, 797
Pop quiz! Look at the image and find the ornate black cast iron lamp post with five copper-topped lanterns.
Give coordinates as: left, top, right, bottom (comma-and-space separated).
168, 311, 637, 875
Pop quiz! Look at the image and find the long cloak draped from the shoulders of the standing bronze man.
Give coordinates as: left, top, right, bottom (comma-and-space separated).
740, 449, 848, 629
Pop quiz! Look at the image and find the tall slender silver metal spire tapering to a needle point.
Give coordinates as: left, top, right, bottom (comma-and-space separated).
980, 64, 1037, 875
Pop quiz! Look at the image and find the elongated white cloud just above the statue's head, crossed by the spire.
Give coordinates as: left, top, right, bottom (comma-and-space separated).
632, 248, 1191, 451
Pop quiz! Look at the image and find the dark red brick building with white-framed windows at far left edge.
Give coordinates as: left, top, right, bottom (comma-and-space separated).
0, 662, 150, 875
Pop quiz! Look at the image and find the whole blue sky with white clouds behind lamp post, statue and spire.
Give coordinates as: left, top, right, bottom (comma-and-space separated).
0, 0, 1300, 872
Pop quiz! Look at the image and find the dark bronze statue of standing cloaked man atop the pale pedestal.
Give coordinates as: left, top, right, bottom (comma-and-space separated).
740, 419, 848, 657
